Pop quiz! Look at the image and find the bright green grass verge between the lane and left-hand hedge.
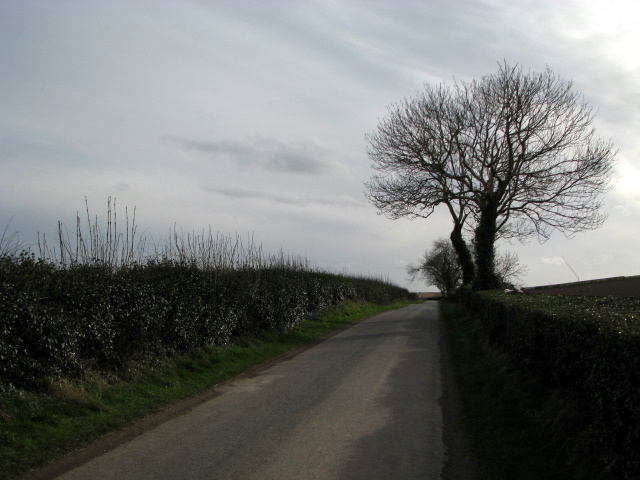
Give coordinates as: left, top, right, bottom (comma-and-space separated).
0, 302, 408, 480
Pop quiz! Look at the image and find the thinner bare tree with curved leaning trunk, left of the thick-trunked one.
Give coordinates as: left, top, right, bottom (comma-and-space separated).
365, 85, 475, 284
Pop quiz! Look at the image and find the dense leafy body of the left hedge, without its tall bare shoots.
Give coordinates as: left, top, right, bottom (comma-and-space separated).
0, 256, 408, 388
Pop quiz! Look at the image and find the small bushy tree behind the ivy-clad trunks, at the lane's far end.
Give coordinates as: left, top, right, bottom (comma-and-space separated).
407, 238, 462, 295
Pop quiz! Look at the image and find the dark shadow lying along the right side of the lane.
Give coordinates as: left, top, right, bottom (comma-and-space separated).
339, 305, 477, 480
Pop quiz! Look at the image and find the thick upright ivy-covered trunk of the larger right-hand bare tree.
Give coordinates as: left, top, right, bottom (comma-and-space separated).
473, 204, 501, 290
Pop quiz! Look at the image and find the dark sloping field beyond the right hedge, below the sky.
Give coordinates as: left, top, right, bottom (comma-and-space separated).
527, 276, 640, 298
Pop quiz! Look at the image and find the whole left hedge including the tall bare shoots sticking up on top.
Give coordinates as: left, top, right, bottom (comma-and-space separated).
0, 202, 409, 390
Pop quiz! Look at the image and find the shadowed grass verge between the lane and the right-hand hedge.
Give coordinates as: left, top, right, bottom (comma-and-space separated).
440, 301, 589, 480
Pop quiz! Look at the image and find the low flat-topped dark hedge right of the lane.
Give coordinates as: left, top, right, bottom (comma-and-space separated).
464, 292, 640, 479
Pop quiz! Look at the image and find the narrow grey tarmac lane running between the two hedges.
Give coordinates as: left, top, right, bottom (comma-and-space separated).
51, 302, 470, 480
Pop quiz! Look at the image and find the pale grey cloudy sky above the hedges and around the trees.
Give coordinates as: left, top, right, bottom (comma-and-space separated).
0, 0, 640, 291
